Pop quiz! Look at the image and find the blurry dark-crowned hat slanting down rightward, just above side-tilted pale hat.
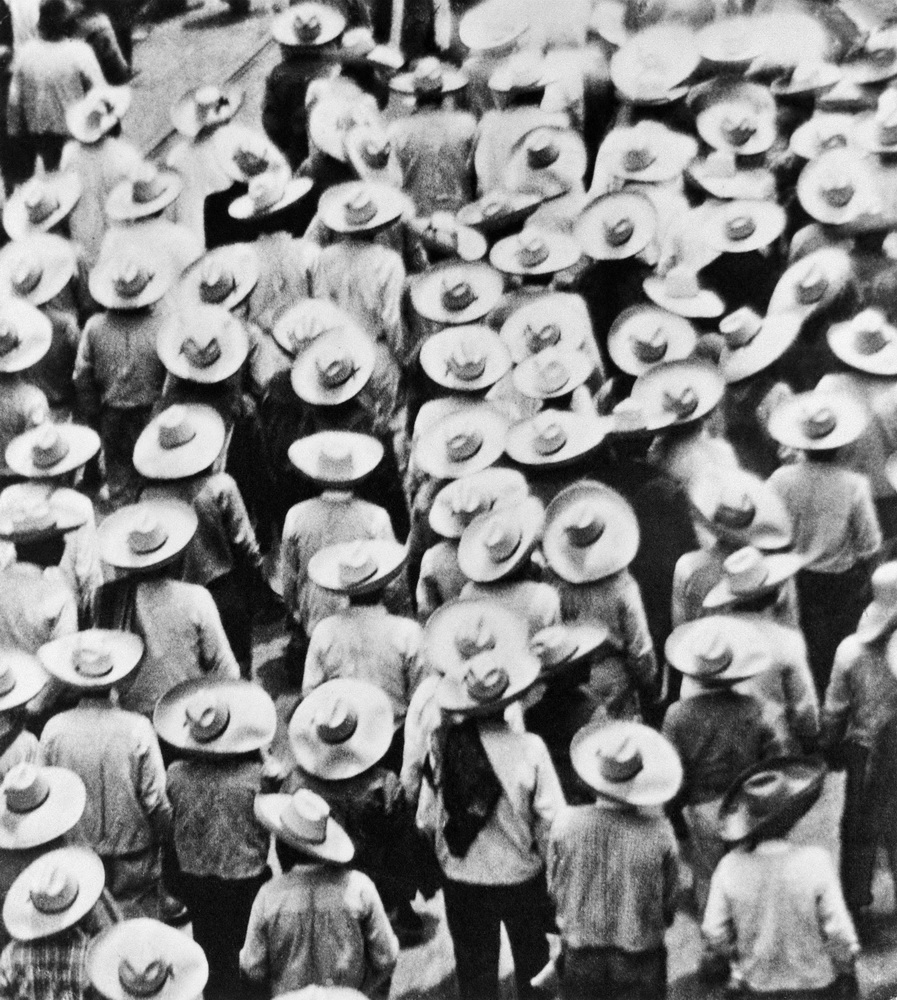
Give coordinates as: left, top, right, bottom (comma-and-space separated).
688, 469, 792, 552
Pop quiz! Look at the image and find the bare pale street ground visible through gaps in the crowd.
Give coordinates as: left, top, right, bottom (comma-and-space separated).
117, 0, 897, 1000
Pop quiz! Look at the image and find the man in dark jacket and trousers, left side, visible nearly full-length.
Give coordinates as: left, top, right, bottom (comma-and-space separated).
74, 244, 175, 506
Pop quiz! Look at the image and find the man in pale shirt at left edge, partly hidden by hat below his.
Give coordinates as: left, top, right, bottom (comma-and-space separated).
0, 422, 103, 621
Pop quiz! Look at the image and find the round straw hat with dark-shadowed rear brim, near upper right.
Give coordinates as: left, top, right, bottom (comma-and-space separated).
693, 79, 776, 156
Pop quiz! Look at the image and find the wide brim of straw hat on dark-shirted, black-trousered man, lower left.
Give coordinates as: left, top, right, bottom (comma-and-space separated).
153, 677, 277, 757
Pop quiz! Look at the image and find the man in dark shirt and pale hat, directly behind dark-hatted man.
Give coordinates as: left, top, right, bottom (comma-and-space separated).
663, 615, 786, 913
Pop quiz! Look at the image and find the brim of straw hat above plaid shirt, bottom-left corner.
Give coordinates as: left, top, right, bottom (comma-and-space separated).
3, 847, 106, 941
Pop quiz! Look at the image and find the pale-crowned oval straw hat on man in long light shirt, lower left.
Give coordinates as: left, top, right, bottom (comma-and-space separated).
38, 628, 143, 691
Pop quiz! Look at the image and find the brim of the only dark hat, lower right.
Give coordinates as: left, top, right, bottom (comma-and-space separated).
718, 757, 827, 844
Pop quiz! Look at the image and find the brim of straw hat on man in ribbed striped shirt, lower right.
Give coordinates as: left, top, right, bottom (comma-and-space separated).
570, 722, 682, 807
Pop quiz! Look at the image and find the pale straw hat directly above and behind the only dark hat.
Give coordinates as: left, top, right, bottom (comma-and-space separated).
664, 615, 774, 685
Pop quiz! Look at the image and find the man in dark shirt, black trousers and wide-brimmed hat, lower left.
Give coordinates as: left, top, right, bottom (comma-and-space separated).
153, 678, 285, 997
